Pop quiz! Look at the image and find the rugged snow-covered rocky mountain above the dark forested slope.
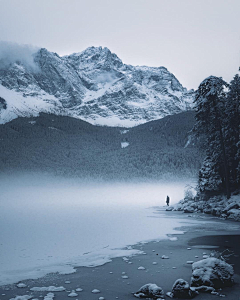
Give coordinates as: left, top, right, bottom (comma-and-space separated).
0, 47, 194, 127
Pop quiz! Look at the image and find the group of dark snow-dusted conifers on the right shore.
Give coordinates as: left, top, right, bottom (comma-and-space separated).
194, 75, 240, 198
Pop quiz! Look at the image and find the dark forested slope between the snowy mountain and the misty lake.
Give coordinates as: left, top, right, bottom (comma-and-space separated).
0, 111, 200, 180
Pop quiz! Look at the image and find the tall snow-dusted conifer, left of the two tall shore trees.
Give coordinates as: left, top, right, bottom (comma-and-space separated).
194, 76, 231, 198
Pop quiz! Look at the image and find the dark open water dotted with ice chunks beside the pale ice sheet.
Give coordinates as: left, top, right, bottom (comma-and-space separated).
0, 211, 240, 300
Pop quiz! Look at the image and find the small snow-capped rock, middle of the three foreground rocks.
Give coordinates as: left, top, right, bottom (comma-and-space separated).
171, 279, 197, 299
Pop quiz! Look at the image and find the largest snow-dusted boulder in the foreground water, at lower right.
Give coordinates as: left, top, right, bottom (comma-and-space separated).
191, 257, 234, 289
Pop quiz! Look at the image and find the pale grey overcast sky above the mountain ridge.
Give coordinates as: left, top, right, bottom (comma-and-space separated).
0, 0, 240, 89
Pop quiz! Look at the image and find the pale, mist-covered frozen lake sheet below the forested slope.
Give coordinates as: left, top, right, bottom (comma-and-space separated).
0, 176, 195, 285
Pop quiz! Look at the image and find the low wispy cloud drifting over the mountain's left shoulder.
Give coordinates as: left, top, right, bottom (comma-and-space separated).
0, 41, 39, 71
